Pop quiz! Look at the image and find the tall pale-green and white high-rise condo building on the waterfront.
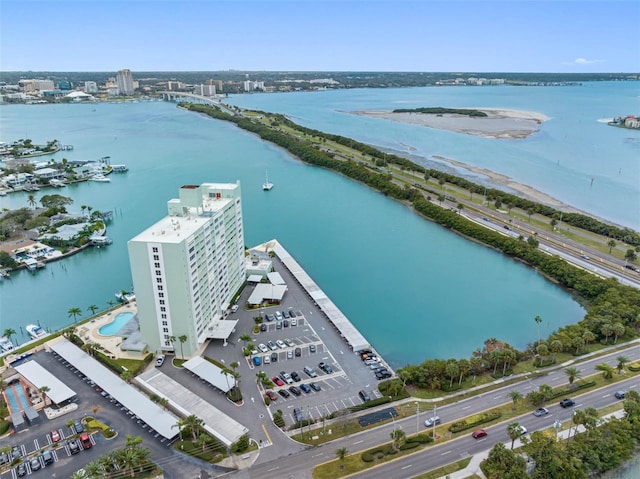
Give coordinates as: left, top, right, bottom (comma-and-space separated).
128, 182, 246, 356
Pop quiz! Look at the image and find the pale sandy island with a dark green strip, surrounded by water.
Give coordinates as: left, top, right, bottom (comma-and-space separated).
353, 108, 548, 140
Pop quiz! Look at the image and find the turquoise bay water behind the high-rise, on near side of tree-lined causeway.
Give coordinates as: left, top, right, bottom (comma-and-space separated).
0, 90, 596, 367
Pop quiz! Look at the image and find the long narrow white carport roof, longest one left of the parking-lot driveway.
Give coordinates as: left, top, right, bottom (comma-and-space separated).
51, 339, 178, 439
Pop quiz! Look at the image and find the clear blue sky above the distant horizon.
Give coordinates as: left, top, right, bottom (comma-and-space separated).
0, 0, 640, 72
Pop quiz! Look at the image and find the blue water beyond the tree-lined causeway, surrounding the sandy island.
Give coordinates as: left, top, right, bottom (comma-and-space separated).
225, 82, 640, 230
